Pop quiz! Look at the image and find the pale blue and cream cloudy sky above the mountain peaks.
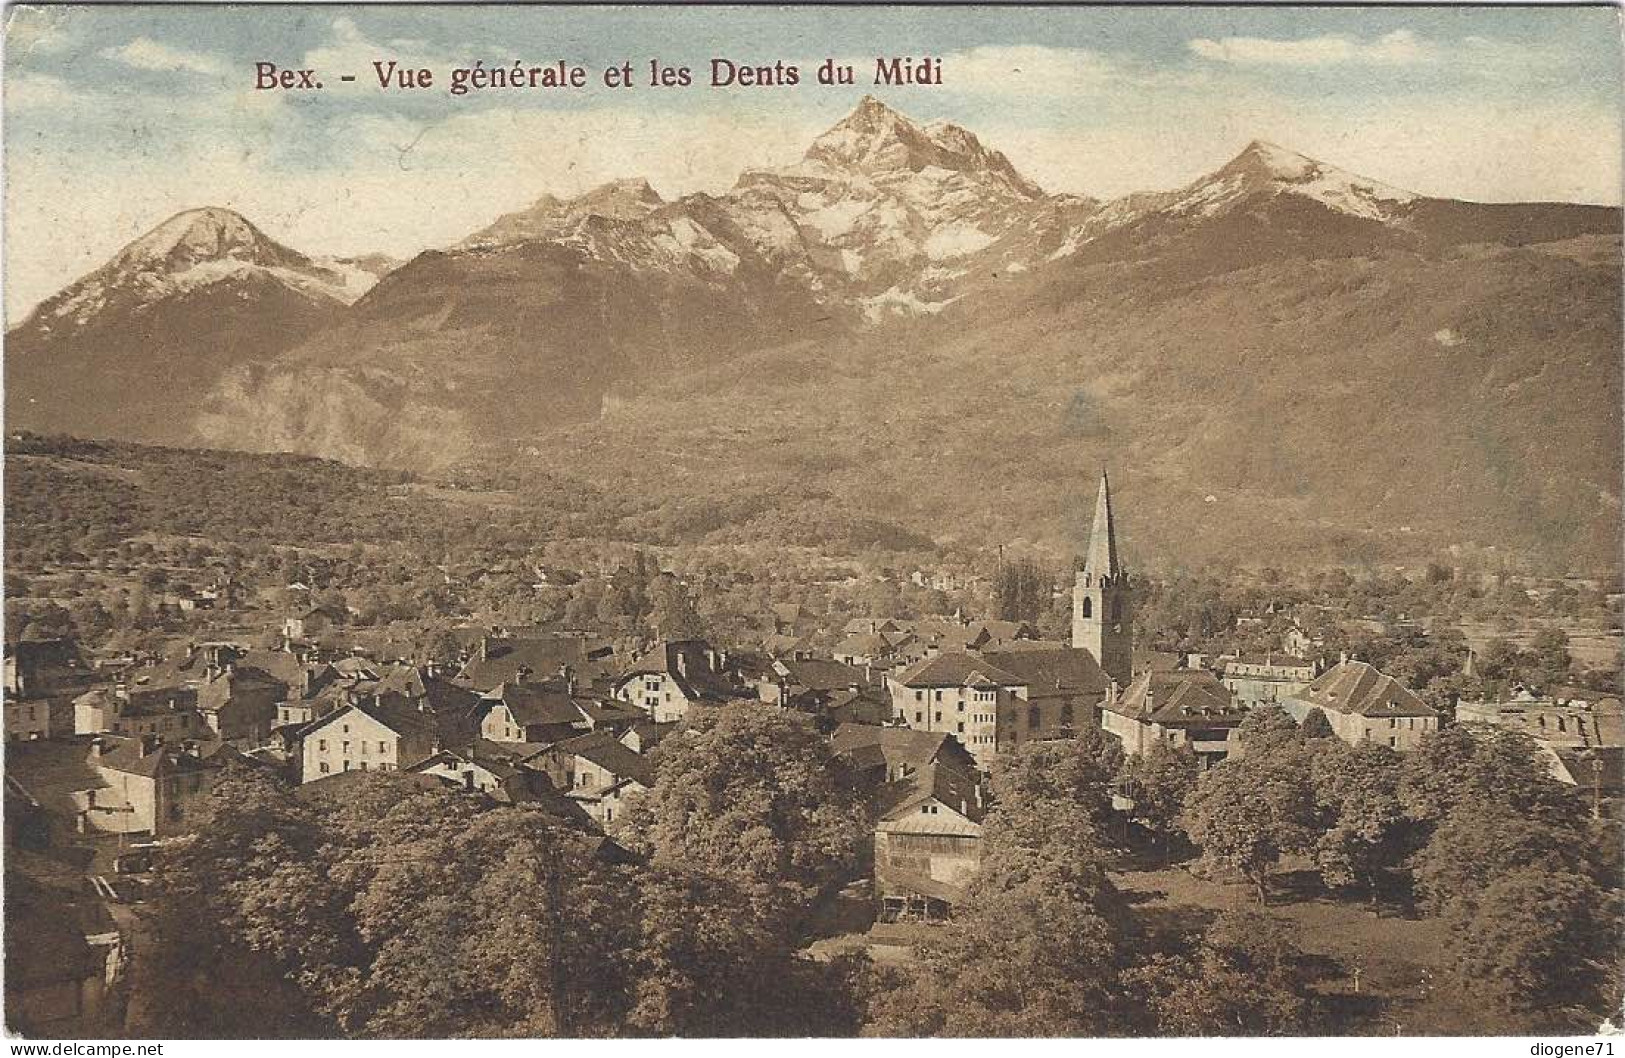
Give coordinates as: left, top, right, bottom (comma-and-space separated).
3, 5, 1622, 318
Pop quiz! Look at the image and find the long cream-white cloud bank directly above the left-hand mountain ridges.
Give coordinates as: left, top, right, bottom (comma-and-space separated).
5, 104, 827, 322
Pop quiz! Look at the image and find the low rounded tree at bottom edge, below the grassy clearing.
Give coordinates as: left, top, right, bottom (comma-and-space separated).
1125, 912, 1310, 1035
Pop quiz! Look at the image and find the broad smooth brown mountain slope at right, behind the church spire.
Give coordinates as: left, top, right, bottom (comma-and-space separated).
535, 237, 1625, 569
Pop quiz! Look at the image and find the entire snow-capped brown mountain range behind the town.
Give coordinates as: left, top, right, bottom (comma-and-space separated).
7, 98, 1622, 566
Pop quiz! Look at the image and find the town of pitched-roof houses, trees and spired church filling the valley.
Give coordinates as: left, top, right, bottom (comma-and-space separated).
5, 448, 1625, 1038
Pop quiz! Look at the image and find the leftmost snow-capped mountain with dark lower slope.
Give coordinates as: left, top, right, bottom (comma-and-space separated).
5, 208, 387, 444
